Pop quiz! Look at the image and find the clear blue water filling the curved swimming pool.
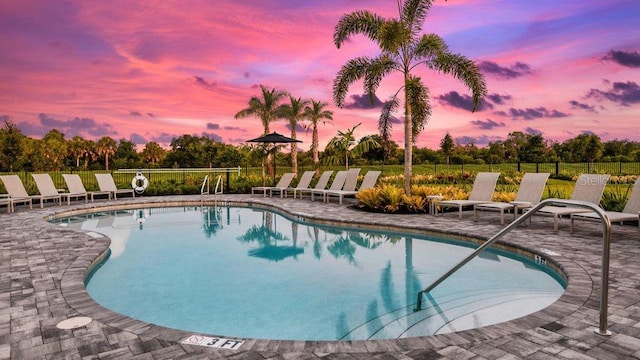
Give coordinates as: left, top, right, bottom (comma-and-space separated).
56, 207, 564, 340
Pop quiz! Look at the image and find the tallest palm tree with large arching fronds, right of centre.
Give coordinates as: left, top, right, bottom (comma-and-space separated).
333, 0, 487, 194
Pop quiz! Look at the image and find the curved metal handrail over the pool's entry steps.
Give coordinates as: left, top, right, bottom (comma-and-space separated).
414, 199, 611, 336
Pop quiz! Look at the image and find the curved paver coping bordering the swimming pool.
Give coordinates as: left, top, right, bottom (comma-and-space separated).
55, 195, 593, 353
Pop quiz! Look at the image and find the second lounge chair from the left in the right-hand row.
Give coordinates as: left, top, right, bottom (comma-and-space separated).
473, 173, 550, 225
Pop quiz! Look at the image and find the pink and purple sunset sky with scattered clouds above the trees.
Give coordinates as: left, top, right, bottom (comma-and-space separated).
0, 0, 640, 150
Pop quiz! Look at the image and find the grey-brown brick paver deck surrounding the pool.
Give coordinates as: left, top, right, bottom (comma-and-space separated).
0, 195, 640, 360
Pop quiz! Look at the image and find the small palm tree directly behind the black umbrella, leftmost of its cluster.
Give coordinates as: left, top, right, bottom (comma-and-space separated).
234, 85, 287, 181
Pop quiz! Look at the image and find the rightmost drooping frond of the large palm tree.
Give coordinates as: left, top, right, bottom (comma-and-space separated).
433, 53, 487, 111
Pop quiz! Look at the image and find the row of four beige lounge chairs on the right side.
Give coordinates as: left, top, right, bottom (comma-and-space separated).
436, 172, 640, 230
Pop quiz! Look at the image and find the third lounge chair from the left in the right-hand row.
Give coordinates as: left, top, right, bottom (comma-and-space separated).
535, 174, 609, 231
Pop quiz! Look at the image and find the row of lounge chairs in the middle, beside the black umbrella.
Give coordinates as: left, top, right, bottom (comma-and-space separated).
251, 168, 381, 204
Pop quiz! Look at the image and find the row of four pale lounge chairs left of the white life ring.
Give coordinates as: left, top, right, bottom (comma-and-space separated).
0, 174, 135, 213
